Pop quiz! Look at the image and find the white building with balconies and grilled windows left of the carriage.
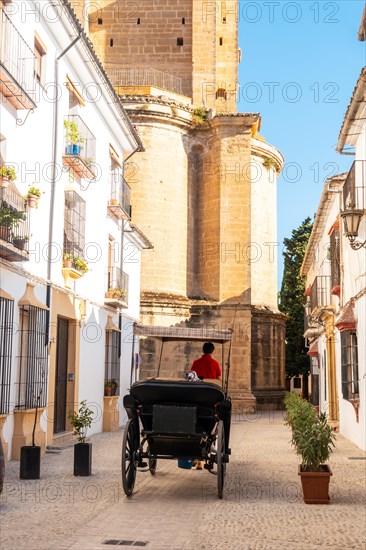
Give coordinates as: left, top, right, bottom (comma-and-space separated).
0, 0, 151, 459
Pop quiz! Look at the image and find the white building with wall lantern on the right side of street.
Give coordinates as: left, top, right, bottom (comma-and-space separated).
302, 63, 366, 449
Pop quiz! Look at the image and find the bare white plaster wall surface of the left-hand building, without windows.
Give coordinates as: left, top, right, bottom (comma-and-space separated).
0, 1, 146, 458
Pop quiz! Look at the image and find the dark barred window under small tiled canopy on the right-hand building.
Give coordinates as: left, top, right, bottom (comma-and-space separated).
341, 330, 359, 399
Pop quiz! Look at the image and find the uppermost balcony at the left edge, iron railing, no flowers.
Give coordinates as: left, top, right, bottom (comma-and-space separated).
0, 10, 36, 109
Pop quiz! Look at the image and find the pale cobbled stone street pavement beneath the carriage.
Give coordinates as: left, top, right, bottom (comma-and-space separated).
0, 411, 366, 550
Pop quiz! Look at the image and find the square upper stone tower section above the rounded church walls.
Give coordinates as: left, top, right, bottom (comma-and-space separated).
89, 0, 239, 113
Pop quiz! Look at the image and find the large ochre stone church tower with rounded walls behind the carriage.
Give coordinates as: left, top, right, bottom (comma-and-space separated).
70, 0, 285, 412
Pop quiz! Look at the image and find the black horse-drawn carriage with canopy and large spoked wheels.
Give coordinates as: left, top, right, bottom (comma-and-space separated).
122, 324, 232, 498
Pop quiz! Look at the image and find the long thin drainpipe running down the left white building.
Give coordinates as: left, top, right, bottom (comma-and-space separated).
46, 33, 82, 344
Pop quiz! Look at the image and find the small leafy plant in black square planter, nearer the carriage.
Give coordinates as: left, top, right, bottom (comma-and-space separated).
68, 399, 94, 476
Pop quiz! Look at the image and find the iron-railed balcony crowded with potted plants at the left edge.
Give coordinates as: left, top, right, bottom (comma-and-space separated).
0, 184, 29, 262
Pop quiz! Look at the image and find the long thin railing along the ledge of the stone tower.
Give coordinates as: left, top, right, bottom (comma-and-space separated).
108, 67, 183, 94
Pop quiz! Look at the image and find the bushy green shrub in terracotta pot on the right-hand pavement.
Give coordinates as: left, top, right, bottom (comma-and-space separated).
285, 396, 335, 504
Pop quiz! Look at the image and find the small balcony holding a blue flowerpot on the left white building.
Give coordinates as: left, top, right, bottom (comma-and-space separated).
63, 115, 96, 179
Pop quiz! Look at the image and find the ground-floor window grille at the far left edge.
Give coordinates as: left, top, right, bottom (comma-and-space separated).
0, 297, 14, 414
